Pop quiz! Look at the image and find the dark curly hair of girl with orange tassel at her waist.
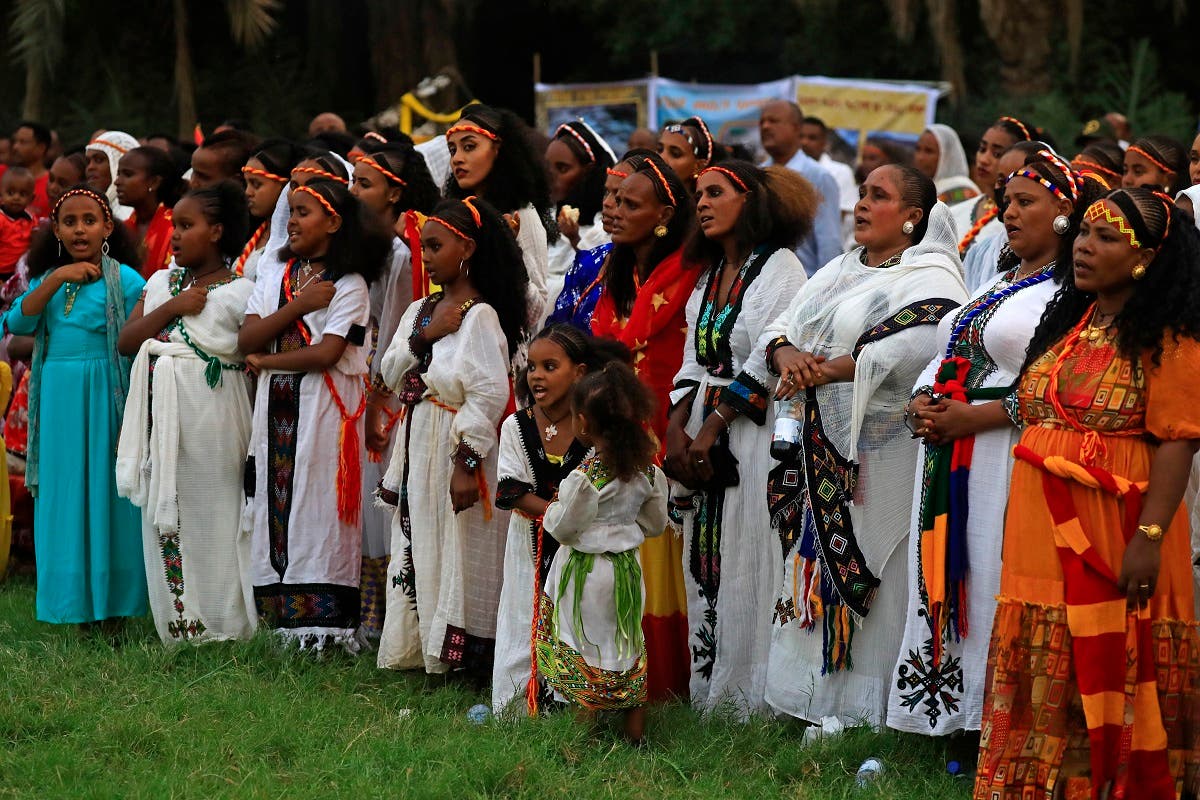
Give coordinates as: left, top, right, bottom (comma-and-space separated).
280, 179, 391, 283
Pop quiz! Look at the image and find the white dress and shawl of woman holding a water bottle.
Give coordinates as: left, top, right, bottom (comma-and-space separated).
766, 203, 967, 726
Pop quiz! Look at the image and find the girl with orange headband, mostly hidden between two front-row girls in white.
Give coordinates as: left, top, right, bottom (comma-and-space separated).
350, 140, 438, 643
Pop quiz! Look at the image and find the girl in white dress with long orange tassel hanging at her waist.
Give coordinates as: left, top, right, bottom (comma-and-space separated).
238, 180, 386, 649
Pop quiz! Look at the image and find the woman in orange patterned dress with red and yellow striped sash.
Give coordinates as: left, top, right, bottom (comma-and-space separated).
974, 188, 1200, 800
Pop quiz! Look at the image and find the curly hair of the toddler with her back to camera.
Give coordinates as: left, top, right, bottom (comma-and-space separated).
571, 361, 659, 481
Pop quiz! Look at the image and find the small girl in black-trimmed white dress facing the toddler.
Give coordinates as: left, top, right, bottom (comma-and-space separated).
492, 324, 630, 714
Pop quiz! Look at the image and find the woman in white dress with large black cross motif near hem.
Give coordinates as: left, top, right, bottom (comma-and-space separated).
887, 151, 1100, 735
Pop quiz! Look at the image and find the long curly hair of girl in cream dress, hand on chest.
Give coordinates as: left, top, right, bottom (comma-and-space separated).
430, 198, 529, 359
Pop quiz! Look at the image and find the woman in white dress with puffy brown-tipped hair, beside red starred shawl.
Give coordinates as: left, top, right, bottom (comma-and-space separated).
665, 161, 817, 718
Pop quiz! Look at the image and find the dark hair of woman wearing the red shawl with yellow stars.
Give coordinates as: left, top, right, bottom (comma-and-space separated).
604, 151, 696, 317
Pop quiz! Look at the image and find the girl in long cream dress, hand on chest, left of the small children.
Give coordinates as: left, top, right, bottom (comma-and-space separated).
379, 198, 528, 680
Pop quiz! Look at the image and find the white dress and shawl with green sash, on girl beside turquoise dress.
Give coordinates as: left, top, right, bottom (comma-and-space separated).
116, 270, 257, 644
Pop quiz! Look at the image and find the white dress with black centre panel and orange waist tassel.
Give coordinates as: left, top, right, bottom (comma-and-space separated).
244, 259, 371, 649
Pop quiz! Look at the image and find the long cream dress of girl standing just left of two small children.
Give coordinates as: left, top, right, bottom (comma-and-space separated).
379, 294, 510, 673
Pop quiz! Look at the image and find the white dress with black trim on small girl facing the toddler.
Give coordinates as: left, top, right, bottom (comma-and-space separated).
492, 408, 589, 714
